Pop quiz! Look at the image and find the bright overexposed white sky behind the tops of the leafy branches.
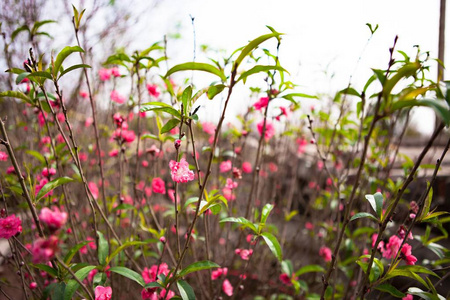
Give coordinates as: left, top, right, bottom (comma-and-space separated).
133, 0, 442, 132
